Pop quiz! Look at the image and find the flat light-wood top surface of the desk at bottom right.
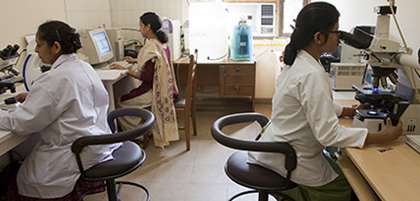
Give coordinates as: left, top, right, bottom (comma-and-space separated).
344, 136, 420, 201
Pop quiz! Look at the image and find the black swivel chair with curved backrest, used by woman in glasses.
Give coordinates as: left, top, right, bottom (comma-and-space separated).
211, 113, 298, 201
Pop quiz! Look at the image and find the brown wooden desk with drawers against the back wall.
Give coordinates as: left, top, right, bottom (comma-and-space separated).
174, 58, 256, 111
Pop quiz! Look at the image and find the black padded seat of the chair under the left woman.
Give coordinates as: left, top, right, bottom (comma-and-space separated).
85, 141, 146, 180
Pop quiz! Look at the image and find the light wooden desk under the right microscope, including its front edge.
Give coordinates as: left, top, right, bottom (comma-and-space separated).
336, 101, 420, 201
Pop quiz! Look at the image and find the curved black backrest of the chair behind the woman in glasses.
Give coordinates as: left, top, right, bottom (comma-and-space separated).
211, 113, 297, 180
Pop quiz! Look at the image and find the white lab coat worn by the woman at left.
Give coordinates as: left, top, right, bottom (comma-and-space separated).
0, 54, 121, 198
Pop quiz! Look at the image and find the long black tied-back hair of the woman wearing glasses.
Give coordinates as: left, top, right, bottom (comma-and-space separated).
284, 2, 340, 65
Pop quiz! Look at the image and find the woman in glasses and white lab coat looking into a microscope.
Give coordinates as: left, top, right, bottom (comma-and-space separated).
249, 2, 402, 201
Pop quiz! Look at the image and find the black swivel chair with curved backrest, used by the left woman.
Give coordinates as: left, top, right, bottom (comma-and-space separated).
71, 108, 155, 201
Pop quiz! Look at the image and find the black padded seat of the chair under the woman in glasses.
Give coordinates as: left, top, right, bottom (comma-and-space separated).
225, 151, 297, 191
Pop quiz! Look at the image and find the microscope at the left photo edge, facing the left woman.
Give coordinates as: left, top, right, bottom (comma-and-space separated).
0, 44, 23, 94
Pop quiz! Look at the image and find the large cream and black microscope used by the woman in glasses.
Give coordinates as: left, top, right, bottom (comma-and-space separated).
340, 0, 420, 134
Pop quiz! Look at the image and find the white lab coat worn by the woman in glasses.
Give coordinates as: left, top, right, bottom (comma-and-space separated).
249, 50, 367, 186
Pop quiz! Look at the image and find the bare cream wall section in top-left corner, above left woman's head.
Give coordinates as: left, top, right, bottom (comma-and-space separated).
0, 0, 66, 49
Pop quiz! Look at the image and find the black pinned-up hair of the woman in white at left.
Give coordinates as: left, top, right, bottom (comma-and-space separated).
38, 21, 82, 54
